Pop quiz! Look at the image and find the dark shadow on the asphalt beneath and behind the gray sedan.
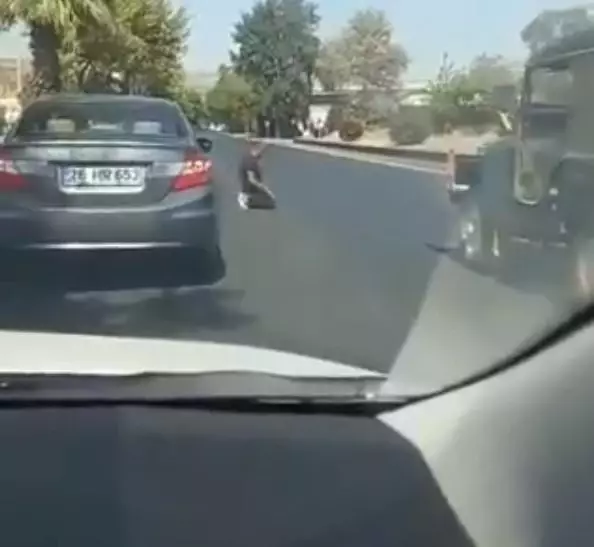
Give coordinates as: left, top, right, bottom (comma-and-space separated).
0, 252, 253, 339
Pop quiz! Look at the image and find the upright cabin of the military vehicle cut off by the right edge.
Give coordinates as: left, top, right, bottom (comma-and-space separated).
516, 30, 594, 231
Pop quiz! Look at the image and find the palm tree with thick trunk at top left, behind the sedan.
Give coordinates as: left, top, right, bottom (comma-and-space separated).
0, 0, 117, 94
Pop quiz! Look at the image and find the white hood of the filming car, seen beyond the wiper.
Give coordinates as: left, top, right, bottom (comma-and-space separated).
0, 331, 385, 380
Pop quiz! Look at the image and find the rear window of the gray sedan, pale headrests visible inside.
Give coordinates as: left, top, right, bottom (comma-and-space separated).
14, 101, 188, 140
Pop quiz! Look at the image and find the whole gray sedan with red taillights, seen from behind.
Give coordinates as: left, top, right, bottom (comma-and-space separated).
0, 94, 220, 278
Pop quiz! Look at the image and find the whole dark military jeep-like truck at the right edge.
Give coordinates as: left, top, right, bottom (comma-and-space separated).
449, 30, 594, 294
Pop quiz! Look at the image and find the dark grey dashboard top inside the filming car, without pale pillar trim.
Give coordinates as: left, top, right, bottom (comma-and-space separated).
0, 407, 470, 547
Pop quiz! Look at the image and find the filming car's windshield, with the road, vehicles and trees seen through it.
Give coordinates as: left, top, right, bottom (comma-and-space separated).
0, 0, 594, 395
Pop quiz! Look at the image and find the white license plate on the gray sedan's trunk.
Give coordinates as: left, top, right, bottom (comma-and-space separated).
60, 167, 146, 192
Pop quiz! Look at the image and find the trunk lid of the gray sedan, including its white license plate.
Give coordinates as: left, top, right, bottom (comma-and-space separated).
2, 140, 186, 208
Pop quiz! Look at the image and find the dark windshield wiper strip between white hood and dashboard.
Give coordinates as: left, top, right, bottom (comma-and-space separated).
0, 371, 406, 414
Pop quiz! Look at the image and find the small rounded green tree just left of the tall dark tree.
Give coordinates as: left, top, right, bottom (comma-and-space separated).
206, 67, 259, 131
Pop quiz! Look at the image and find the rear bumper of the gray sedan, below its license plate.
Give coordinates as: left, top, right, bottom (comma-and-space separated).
0, 197, 219, 251
